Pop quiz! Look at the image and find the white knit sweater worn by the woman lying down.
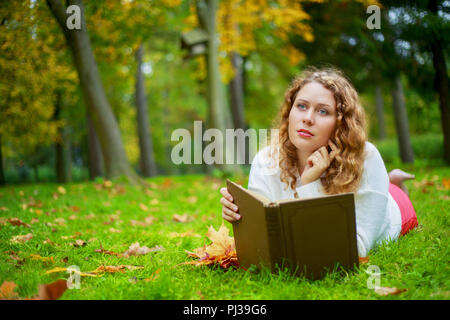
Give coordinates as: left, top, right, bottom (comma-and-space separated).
248, 142, 402, 257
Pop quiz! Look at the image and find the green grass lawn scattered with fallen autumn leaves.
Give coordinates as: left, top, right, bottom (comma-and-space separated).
0, 167, 450, 299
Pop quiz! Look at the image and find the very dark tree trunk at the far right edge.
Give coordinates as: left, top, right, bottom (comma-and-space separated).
428, 0, 450, 165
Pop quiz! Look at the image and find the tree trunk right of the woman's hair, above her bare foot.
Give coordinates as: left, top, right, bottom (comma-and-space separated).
392, 76, 414, 163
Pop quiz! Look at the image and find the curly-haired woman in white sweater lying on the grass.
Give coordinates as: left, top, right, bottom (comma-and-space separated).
220, 68, 417, 257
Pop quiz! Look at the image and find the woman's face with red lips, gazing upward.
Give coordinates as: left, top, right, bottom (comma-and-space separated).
289, 82, 337, 154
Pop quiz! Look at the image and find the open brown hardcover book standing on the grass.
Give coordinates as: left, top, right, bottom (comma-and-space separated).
227, 179, 358, 279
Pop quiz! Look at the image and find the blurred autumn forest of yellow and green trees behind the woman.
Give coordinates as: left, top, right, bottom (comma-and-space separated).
0, 0, 450, 184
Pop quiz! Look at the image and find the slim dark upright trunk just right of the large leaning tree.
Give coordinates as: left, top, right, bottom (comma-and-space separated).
136, 44, 157, 177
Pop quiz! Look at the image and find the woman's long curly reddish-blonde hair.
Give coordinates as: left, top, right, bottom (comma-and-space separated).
268, 67, 367, 198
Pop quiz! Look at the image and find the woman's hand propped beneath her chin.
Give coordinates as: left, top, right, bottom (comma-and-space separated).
301, 140, 338, 185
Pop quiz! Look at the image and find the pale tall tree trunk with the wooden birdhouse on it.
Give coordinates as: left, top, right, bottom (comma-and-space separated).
196, 0, 240, 173
